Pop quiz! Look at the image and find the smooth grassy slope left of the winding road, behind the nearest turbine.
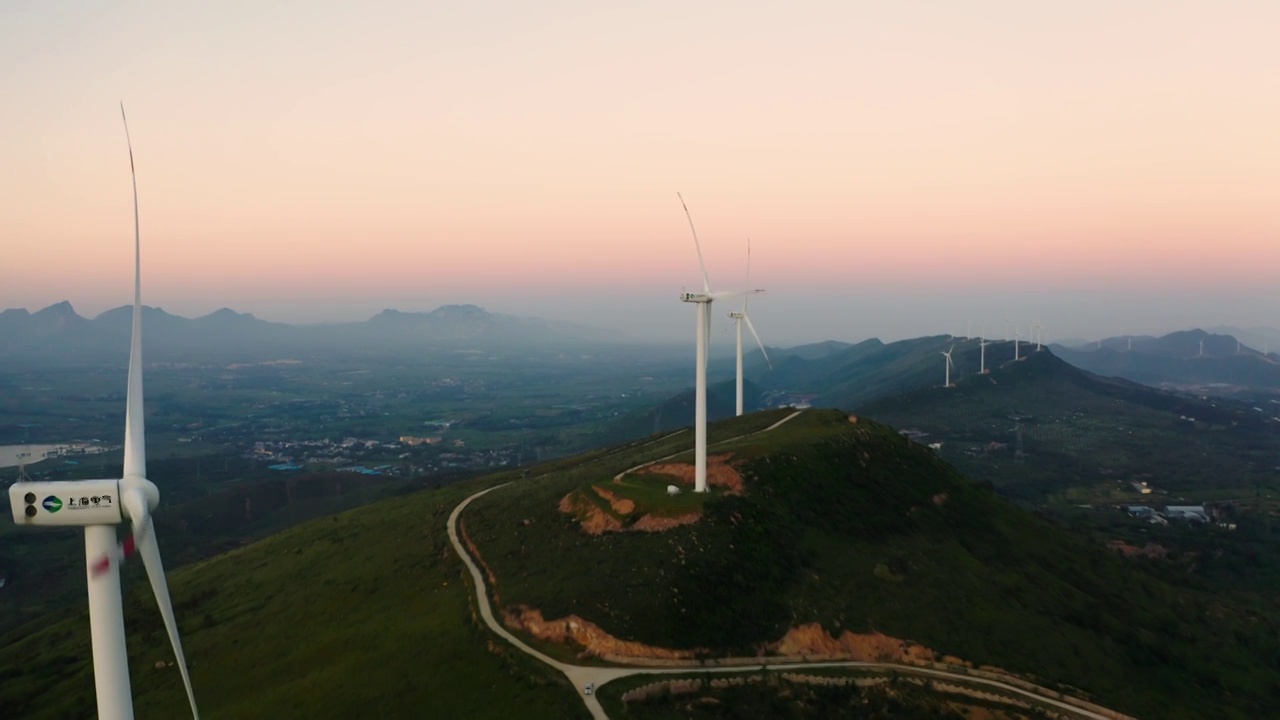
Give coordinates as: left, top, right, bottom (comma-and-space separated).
0, 482, 588, 720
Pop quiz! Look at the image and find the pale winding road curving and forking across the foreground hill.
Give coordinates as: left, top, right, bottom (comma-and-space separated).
448, 411, 1116, 720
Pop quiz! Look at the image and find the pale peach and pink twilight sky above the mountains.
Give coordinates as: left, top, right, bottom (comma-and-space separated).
0, 0, 1280, 345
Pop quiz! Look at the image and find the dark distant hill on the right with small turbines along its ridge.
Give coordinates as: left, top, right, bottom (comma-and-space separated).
858, 348, 1280, 502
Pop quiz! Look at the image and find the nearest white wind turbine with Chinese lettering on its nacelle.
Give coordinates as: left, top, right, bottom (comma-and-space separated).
9, 104, 200, 720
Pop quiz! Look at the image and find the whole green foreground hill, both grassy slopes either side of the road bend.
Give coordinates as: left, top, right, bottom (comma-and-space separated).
0, 410, 1280, 719
